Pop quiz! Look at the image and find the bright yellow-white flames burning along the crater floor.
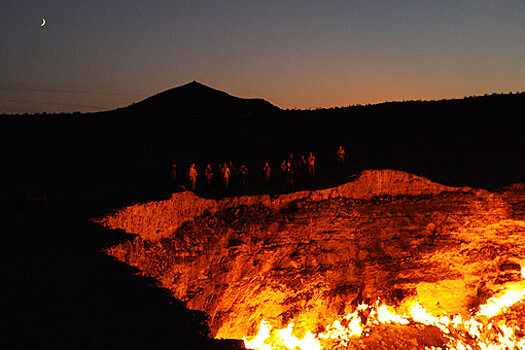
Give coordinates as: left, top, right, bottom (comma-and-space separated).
244, 267, 525, 350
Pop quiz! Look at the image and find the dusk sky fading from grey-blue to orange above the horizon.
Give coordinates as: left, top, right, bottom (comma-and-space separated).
0, 0, 525, 113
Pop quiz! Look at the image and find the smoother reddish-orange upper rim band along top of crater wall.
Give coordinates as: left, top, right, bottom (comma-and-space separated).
98, 170, 466, 241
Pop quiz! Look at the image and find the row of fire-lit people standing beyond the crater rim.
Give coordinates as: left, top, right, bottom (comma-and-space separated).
170, 146, 345, 192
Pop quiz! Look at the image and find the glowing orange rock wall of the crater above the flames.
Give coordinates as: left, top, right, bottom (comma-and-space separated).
101, 170, 525, 348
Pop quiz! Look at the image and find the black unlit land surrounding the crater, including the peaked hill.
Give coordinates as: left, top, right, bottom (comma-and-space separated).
0, 83, 525, 348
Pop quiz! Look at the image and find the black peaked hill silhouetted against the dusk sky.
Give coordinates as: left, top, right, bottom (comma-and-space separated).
113, 81, 279, 119
